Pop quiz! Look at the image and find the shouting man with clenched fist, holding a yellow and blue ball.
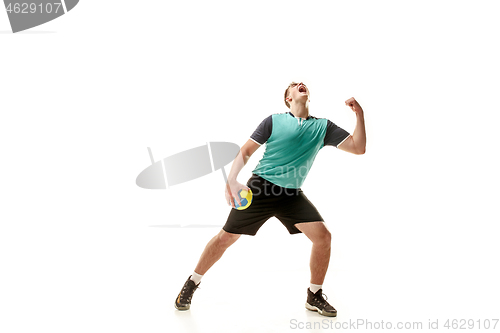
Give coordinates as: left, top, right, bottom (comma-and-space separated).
175, 82, 366, 317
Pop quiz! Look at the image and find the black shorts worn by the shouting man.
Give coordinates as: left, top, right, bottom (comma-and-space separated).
222, 174, 323, 236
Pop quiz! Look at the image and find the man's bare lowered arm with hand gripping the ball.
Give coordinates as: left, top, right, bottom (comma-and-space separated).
226, 139, 260, 207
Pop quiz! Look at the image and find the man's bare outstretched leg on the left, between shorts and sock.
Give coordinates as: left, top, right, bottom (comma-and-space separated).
194, 229, 241, 275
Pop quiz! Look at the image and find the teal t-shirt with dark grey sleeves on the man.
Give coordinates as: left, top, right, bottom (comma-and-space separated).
250, 112, 349, 188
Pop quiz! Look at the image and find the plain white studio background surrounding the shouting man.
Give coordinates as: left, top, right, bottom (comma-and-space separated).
0, 1, 500, 332
